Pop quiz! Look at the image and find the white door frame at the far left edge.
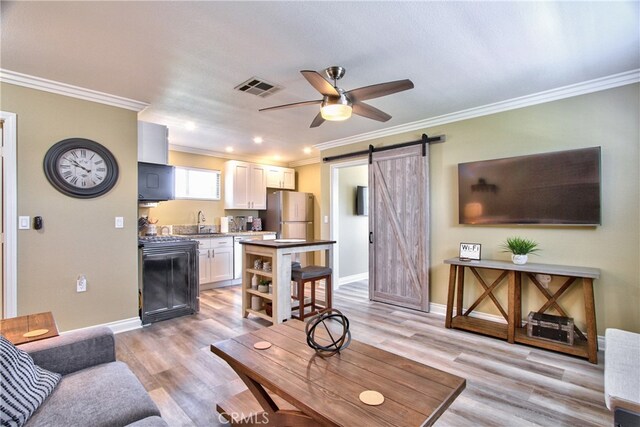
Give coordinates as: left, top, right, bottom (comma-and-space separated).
0, 111, 18, 318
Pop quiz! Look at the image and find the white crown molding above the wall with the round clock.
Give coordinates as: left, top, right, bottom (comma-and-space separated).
0, 68, 149, 112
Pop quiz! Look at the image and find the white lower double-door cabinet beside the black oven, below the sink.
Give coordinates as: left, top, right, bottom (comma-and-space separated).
198, 237, 233, 284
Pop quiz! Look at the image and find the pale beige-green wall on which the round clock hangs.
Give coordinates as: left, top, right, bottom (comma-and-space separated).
0, 83, 138, 331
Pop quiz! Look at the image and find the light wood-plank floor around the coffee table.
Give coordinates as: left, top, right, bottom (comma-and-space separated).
116, 282, 613, 427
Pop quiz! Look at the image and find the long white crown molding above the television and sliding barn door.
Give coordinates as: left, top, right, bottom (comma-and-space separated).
313, 69, 640, 151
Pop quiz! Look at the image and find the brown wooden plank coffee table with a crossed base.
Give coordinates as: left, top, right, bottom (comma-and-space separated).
211, 320, 466, 426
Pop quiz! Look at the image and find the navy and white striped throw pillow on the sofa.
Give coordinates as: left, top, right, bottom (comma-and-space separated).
0, 335, 61, 427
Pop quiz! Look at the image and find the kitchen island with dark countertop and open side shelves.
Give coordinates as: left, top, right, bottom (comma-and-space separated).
240, 239, 336, 324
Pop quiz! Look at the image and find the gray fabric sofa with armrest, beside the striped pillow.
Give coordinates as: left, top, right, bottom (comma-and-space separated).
18, 327, 167, 427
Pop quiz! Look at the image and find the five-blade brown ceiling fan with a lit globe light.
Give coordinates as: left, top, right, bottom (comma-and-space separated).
258, 66, 413, 128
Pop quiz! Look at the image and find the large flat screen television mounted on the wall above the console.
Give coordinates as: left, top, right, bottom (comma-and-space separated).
458, 147, 601, 226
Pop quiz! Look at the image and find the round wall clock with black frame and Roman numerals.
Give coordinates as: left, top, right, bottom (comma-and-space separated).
44, 138, 118, 199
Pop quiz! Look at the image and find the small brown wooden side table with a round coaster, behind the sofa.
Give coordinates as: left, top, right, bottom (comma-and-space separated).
0, 311, 58, 345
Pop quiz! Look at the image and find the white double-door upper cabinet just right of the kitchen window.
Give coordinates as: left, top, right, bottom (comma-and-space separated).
224, 160, 267, 210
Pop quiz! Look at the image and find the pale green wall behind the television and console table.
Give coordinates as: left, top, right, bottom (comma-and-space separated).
321, 84, 640, 335
